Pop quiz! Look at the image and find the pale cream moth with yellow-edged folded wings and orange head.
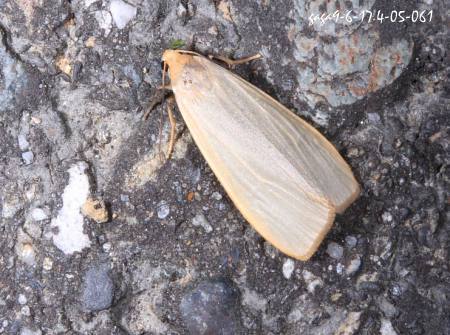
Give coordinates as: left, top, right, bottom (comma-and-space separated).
162, 50, 360, 260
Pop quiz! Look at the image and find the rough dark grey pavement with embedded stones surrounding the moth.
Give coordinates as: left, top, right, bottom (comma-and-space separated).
0, 0, 450, 335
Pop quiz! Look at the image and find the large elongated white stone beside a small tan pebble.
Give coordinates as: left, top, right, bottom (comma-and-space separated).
51, 162, 91, 255
